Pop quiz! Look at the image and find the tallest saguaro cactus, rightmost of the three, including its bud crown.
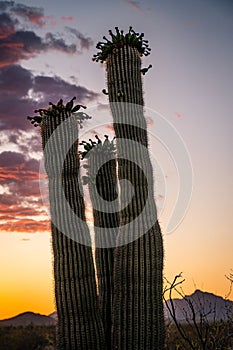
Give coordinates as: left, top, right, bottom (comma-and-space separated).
93, 27, 164, 350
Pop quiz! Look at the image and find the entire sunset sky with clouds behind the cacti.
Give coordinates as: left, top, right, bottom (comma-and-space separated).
0, 0, 233, 319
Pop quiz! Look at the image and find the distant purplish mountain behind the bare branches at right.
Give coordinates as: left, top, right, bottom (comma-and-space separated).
165, 289, 233, 322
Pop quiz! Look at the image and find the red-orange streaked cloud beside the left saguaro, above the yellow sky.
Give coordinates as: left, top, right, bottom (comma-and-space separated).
0, 151, 47, 231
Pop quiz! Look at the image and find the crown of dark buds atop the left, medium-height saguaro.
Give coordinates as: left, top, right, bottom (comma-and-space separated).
27, 97, 91, 128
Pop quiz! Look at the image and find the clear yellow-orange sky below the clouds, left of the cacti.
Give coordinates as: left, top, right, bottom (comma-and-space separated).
0, 233, 55, 319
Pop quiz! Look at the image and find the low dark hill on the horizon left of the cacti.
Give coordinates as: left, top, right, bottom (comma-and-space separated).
0, 312, 56, 327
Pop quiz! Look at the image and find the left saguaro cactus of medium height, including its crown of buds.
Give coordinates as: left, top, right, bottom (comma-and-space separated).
28, 99, 105, 350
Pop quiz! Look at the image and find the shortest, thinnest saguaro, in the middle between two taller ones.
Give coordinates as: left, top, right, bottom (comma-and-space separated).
80, 135, 119, 350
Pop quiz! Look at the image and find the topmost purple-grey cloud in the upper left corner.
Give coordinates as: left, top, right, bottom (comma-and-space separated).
0, 1, 93, 67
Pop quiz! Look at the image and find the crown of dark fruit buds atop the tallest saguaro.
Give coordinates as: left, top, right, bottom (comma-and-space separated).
92, 27, 151, 63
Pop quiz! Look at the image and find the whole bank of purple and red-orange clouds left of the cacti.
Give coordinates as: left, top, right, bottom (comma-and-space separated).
0, 1, 98, 232
